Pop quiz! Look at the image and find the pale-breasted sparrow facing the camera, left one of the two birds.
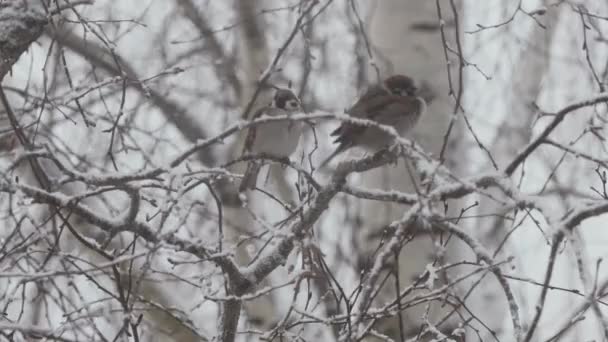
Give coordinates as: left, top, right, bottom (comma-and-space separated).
239, 89, 304, 192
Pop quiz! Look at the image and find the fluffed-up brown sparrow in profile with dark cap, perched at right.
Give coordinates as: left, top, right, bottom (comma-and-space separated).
321, 75, 426, 167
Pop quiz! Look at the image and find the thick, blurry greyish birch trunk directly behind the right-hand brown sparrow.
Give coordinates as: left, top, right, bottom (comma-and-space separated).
350, 0, 462, 339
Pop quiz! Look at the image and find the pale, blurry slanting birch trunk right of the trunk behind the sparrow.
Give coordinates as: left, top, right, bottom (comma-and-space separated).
465, 2, 558, 340
